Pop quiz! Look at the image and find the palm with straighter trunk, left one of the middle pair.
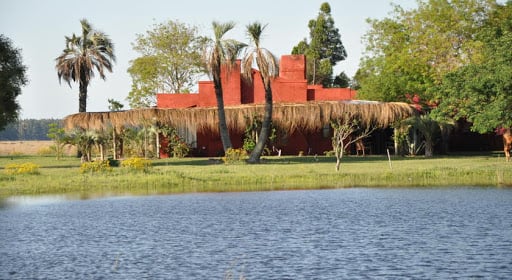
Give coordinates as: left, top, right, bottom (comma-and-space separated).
205, 21, 245, 152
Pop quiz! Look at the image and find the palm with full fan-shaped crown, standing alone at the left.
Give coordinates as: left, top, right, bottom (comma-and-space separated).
55, 19, 116, 112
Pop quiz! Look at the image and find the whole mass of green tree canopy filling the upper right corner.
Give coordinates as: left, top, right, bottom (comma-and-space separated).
356, 0, 512, 136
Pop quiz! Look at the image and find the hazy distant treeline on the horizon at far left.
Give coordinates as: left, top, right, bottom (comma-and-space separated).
0, 119, 62, 141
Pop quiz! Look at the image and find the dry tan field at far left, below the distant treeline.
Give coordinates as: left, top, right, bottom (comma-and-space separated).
0, 141, 76, 156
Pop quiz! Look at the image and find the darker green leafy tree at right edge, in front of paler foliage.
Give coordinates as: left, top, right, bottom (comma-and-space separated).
433, 2, 512, 133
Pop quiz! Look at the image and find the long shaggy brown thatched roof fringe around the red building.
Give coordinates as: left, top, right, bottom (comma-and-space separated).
64, 100, 414, 131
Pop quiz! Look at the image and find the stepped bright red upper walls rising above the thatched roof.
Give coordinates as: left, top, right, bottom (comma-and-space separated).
157, 55, 357, 108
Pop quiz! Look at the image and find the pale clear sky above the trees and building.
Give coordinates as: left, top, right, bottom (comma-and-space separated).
0, 0, 416, 119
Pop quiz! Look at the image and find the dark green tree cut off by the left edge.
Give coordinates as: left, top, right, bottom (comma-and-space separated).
0, 34, 28, 130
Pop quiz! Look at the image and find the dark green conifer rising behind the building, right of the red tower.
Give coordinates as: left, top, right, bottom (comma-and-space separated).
292, 2, 347, 86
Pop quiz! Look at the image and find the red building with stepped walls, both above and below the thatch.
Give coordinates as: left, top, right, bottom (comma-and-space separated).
157, 55, 357, 156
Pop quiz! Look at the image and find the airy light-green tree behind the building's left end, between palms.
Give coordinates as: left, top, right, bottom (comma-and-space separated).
127, 21, 206, 108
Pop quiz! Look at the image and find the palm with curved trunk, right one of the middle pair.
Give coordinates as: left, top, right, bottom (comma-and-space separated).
242, 22, 279, 163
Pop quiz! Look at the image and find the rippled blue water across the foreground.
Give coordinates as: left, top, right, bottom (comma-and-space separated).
0, 188, 512, 279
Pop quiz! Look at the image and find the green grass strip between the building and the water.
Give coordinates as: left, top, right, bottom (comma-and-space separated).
0, 153, 512, 197
